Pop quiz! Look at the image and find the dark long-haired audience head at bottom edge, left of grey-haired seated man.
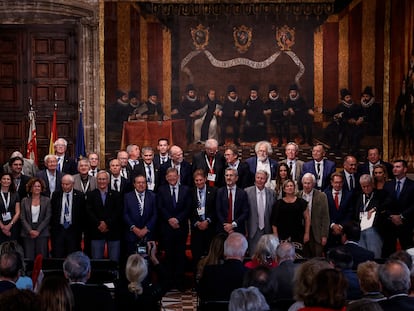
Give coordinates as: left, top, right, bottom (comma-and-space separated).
39, 275, 75, 311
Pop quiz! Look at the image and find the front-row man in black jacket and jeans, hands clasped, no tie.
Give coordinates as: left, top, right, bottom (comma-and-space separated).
85, 170, 123, 262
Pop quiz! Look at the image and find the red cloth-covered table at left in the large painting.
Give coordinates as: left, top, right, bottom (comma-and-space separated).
121, 120, 187, 150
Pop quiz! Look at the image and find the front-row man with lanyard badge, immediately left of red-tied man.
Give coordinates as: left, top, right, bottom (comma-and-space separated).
190, 169, 217, 265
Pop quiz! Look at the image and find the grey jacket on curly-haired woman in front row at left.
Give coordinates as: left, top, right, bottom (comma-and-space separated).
20, 195, 52, 238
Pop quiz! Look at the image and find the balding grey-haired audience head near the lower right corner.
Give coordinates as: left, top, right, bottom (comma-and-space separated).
378, 259, 410, 297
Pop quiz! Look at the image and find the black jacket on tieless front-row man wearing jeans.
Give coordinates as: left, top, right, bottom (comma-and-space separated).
86, 189, 123, 241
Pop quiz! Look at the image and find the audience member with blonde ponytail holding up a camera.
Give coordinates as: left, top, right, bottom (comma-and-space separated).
115, 241, 165, 311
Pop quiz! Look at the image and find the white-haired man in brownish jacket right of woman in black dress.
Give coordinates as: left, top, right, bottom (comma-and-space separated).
298, 173, 330, 257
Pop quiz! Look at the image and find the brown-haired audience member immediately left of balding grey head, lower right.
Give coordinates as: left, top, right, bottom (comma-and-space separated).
357, 261, 385, 301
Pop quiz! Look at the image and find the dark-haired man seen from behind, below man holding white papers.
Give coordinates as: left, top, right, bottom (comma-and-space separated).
342, 221, 375, 270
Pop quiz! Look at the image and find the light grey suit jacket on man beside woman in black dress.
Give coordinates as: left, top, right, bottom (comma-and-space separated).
244, 186, 276, 237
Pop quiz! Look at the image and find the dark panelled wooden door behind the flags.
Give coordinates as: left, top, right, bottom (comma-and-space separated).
0, 25, 78, 168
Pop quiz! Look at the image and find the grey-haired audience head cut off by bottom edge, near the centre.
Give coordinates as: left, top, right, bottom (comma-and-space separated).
229, 286, 270, 311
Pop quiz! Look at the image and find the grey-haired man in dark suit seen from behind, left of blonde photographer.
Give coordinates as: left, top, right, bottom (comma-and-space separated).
63, 252, 114, 311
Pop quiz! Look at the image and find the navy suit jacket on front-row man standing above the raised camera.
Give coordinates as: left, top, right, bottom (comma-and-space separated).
124, 190, 158, 241
